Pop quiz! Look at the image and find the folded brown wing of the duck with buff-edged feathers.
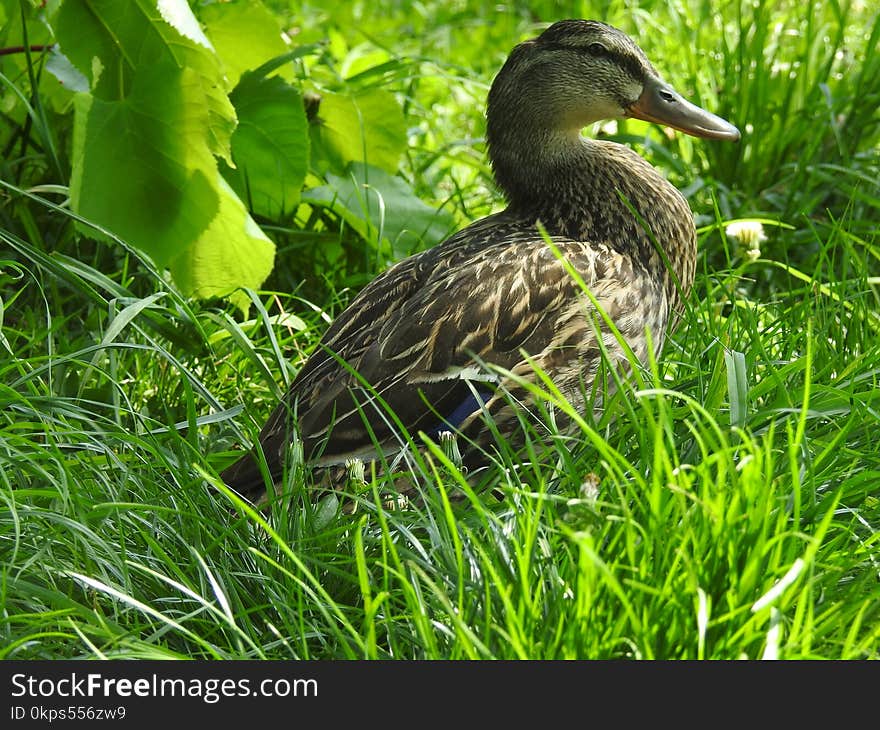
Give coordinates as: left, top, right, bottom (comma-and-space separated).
222, 221, 639, 491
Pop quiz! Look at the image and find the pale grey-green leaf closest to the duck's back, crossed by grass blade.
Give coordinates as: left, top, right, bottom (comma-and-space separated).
302, 162, 454, 258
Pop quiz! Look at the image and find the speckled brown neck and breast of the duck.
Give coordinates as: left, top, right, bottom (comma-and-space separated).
488, 120, 696, 301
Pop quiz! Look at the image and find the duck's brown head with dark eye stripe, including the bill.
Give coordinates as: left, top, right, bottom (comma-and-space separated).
487, 20, 740, 158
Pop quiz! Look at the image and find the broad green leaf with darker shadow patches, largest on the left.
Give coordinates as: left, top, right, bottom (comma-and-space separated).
70, 62, 219, 266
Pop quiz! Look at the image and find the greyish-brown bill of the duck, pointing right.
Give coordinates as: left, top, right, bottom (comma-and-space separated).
626, 78, 740, 142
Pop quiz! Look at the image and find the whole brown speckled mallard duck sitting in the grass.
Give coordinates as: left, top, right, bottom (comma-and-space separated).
221, 20, 739, 498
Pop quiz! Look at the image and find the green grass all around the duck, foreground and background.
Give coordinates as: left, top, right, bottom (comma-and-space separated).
0, 2, 880, 659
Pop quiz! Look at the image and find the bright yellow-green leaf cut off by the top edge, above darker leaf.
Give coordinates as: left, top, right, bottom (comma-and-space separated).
199, 0, 292, 86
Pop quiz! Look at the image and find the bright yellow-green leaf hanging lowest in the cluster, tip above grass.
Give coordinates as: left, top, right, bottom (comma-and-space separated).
171, 173, 275, 310
